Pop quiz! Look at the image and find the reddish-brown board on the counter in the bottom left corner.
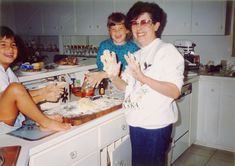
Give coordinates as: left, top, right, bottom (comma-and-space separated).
0, 145, 21, 166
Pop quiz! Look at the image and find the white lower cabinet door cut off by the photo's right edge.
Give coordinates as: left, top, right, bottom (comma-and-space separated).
217, 80, 235, 151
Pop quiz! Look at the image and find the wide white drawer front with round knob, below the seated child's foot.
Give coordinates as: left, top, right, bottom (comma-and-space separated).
29, 129, 98, 166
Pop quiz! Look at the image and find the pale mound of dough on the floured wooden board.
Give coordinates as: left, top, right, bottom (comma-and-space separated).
78, 98, 97, 111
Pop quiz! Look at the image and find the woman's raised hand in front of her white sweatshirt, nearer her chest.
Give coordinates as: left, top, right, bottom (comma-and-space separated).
125, 53, 144, 83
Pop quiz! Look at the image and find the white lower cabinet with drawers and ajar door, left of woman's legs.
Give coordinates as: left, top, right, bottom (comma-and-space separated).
29, 114, 131, 166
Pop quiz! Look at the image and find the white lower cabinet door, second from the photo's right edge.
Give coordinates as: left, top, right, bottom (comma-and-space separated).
197, 80, 220, 144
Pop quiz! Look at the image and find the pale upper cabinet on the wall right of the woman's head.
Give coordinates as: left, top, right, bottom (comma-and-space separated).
162, 0, 226, 35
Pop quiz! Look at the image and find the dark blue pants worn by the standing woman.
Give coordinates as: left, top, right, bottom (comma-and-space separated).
130, 125, 172, 166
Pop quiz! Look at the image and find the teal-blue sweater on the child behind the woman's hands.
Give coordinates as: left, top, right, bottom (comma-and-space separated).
96, 39, 139, 71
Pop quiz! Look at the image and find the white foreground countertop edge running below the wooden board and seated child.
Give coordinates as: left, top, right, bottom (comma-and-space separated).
0, 109, 126, 166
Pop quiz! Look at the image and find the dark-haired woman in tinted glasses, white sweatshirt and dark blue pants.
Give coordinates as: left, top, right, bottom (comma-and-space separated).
102, 2, 184, 166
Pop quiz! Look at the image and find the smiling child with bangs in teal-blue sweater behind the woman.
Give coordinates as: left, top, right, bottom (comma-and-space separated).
87, 12, 139, 86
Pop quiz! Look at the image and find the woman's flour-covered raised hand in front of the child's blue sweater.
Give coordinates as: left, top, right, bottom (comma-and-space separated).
101, 50, 121, 78
